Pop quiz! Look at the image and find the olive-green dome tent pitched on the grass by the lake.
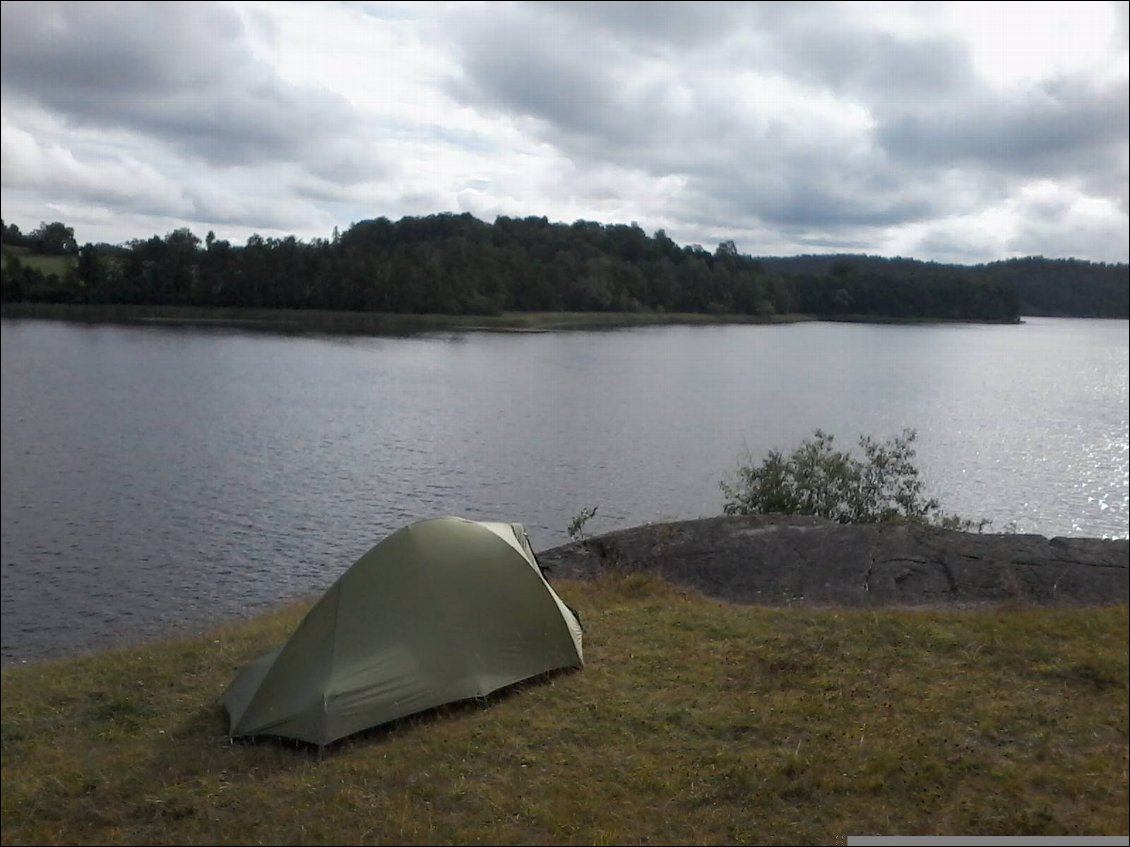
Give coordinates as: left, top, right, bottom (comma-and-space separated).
220, 517, 583, 746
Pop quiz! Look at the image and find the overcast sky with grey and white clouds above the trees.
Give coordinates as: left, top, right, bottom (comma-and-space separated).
0, 0, 1130, 263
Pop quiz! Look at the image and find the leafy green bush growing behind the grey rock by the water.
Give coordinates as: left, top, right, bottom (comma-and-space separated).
721, 429, 985, 530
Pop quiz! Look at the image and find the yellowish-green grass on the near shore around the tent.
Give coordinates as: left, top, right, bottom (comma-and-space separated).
2, 574, 1128, 845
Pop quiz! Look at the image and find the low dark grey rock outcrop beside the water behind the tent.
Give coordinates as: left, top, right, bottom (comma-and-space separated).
538, 515, 1130, 606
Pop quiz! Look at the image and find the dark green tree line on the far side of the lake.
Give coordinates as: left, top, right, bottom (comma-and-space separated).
0, 213, 1127, 321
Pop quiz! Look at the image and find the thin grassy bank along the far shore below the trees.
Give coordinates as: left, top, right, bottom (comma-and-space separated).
0, 303, 809, 335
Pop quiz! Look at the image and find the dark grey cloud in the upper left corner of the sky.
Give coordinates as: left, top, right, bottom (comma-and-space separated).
0, 2, 358, 173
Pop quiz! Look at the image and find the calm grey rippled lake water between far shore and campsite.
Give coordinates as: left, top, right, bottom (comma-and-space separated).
0, 318, 1130, 664
